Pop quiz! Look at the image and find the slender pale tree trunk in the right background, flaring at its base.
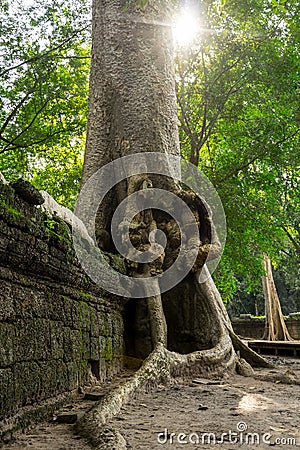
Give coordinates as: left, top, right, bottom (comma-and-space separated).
262, 255, 293, 341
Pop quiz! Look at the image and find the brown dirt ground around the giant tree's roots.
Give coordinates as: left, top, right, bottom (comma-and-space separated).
4, 358, 300, 450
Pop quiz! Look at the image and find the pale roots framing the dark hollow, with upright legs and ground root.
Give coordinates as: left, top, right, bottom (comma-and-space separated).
77, 281, 273, 450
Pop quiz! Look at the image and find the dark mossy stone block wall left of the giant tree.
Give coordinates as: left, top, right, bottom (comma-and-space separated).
0, 181, 123, 431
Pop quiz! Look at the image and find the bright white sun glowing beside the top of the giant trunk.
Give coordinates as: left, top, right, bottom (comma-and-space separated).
173, 10, 199, 47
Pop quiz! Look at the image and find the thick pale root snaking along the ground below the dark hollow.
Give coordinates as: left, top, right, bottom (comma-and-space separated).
76, 333, 254, 450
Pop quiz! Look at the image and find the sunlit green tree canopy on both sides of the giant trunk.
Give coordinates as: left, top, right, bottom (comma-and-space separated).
0, 0, 300, 306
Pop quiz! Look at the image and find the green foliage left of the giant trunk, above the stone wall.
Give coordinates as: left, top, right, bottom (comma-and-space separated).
0, 0, 90, 207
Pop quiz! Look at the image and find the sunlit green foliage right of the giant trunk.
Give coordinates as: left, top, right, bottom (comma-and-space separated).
176, 0, 300, 300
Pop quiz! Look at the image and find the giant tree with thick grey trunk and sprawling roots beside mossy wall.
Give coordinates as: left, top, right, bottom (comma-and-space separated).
74, 0, 266, 442
